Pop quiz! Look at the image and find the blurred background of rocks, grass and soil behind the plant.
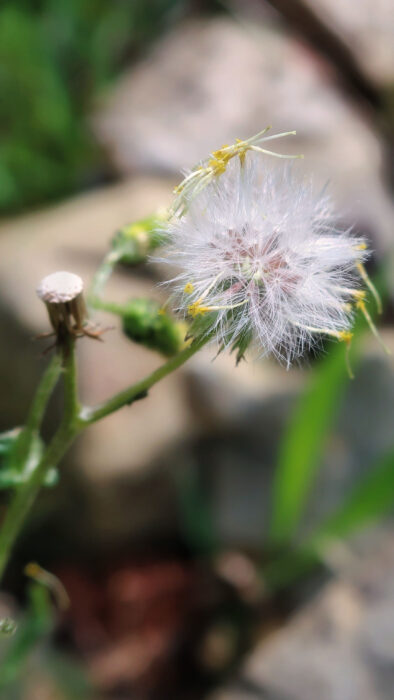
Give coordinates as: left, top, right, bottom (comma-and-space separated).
0, 0, 394, 700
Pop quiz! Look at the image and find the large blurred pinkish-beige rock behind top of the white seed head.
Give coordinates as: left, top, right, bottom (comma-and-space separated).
94, 15, 394, 249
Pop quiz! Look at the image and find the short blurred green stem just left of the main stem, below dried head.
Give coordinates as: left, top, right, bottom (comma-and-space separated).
10, 353, 62, 470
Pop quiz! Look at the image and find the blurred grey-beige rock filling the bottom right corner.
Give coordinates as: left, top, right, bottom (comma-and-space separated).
210, 530, 394, 700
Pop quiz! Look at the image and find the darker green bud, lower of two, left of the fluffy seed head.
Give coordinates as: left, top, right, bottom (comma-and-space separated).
121, 299, 187, 357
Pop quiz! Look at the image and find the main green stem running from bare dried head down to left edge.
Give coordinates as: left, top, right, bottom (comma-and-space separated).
0, 339, 82, 579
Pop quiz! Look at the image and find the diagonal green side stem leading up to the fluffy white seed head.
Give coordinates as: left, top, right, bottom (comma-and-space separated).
80, 338, 207, 425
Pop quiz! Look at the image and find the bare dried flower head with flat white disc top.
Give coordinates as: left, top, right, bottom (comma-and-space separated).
37, 271, 100, 344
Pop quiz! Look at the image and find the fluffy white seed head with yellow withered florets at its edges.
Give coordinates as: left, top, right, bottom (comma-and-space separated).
161, 153, 380, 366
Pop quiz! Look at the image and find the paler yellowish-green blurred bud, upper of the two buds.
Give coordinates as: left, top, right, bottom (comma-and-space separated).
111, 213, 167, 265
